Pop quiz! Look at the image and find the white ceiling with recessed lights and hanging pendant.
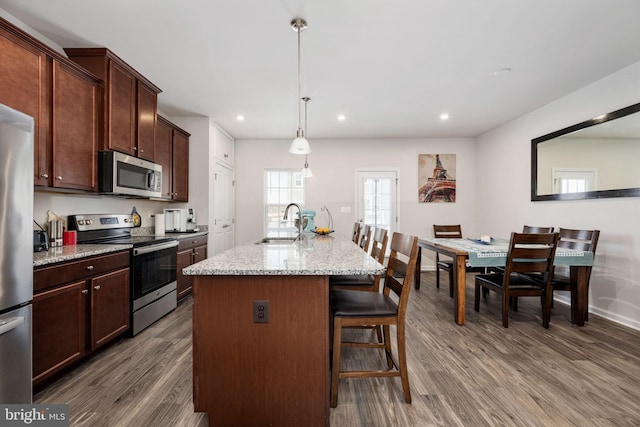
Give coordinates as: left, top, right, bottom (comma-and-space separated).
0, 0, 640, 139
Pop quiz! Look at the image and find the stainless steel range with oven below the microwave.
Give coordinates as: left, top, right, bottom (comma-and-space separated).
68, 214, 178, 336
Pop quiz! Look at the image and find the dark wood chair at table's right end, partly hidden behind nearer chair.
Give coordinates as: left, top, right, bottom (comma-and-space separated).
551, 228, 600, 320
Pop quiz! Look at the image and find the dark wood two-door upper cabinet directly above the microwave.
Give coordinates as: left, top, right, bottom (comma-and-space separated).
65, 48, 161, 161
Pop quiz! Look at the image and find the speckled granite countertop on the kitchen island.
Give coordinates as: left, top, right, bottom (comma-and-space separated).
182, 234, 385, 276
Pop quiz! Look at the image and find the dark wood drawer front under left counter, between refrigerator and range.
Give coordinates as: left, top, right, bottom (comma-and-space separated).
33, 251, 129, 292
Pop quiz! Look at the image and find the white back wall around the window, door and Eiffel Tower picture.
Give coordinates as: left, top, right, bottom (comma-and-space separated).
235, 138, 476, 268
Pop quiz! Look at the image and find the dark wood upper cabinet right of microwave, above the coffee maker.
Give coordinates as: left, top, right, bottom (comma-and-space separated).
156, 116, 191, 202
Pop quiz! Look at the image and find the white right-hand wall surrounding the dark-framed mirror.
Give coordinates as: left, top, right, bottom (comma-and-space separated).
476, 62, 640, 329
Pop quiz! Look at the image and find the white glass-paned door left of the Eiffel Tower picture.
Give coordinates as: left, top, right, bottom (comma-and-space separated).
356, 170, 398, 238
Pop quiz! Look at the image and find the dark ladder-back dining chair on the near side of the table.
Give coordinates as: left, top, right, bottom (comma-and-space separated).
474, 233, 559, 328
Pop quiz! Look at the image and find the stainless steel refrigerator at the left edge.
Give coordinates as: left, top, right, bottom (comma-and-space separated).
0, 104, 34, 403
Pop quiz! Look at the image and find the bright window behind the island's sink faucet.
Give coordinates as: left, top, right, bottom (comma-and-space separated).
264, 169, 305, 235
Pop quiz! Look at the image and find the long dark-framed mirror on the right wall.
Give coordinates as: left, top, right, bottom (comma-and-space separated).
531, 103, 640, 201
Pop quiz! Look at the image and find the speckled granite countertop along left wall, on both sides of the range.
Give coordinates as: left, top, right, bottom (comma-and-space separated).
33, 230, 209, 267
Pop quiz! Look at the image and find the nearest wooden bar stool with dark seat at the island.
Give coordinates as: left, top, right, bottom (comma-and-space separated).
329, 232, 418, 408
